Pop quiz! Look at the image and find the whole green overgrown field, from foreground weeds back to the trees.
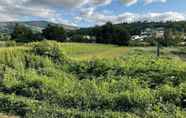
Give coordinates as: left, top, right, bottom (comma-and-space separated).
0, 41, 186, 118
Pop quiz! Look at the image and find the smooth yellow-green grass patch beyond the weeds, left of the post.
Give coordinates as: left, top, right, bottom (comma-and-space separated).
62, 43, 128, 60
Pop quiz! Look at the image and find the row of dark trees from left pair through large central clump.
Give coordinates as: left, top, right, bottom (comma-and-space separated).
11, 23, 130, 45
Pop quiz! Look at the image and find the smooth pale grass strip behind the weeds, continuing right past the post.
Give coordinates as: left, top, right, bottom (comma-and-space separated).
62, 43, 184, 60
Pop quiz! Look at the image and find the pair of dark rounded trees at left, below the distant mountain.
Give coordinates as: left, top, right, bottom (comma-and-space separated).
11, 24, 65, 42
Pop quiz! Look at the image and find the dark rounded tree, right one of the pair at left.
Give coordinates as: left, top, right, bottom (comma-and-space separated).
42, 25, 65, 41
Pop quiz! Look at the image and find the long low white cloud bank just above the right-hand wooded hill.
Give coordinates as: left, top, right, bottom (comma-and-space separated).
81, 11, 186, 25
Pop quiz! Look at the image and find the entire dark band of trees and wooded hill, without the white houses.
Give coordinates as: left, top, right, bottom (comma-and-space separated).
11, 21, 186, 46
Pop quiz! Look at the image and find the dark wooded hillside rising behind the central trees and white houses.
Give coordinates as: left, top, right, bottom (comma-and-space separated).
79, 21, 186, 35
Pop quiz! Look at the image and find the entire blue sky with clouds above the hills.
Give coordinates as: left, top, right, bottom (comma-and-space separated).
0, 0, 186, 27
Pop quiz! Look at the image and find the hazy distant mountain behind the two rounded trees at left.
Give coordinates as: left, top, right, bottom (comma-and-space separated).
0, 21, 78, 33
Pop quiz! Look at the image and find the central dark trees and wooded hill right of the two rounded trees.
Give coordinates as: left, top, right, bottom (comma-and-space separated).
65, 21, 186, 46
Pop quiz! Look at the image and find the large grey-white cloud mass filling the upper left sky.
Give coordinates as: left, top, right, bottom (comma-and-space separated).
0, 0, 112, 24
